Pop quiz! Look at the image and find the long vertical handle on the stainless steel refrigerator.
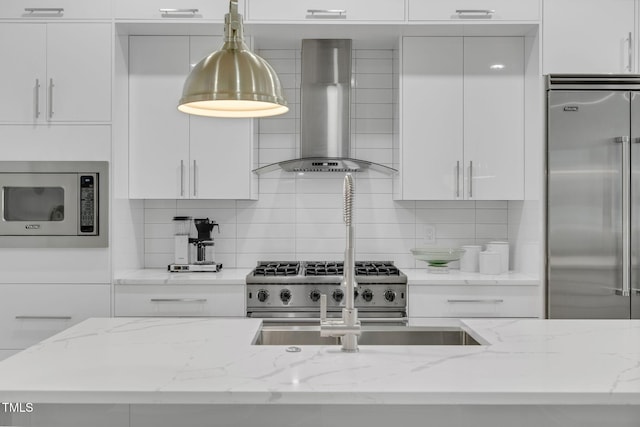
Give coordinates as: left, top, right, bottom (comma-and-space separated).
616, 136, 631, 297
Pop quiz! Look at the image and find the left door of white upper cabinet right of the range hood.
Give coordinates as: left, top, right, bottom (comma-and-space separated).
400, 37, 463, 200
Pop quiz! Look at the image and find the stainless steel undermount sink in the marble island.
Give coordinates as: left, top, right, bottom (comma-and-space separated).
253, 326, 480, 345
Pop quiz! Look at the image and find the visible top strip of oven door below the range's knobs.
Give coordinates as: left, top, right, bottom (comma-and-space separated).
247, 310, 409, 326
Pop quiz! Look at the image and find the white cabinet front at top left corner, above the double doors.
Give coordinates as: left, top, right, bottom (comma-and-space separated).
0, 0, 111, 19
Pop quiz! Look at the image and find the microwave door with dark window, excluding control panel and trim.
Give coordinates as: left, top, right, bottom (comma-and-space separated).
0, 173, 80, 236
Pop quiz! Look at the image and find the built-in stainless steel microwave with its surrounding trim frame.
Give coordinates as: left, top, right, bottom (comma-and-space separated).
0, 161, 109, 248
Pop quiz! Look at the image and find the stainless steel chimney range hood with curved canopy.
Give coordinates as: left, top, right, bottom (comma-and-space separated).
254, 39, 397, 174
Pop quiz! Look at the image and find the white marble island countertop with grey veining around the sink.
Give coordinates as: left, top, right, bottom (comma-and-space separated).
0, 318, 640, 405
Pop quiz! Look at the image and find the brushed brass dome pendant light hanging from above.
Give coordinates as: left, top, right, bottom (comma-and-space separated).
178, 0, 289, 117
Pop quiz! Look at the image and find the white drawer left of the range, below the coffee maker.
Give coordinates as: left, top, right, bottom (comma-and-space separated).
114, 285, 246, 317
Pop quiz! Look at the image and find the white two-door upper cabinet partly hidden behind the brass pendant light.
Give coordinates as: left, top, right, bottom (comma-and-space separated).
129, 36, 257, 199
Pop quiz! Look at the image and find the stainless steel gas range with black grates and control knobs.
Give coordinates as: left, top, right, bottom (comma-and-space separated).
246, 261, 407, 324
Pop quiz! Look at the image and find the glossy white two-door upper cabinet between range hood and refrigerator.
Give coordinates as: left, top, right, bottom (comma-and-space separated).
394, 37, 524, 200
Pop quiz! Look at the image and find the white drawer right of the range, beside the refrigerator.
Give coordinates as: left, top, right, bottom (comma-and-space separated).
409, 285, 541, 317
